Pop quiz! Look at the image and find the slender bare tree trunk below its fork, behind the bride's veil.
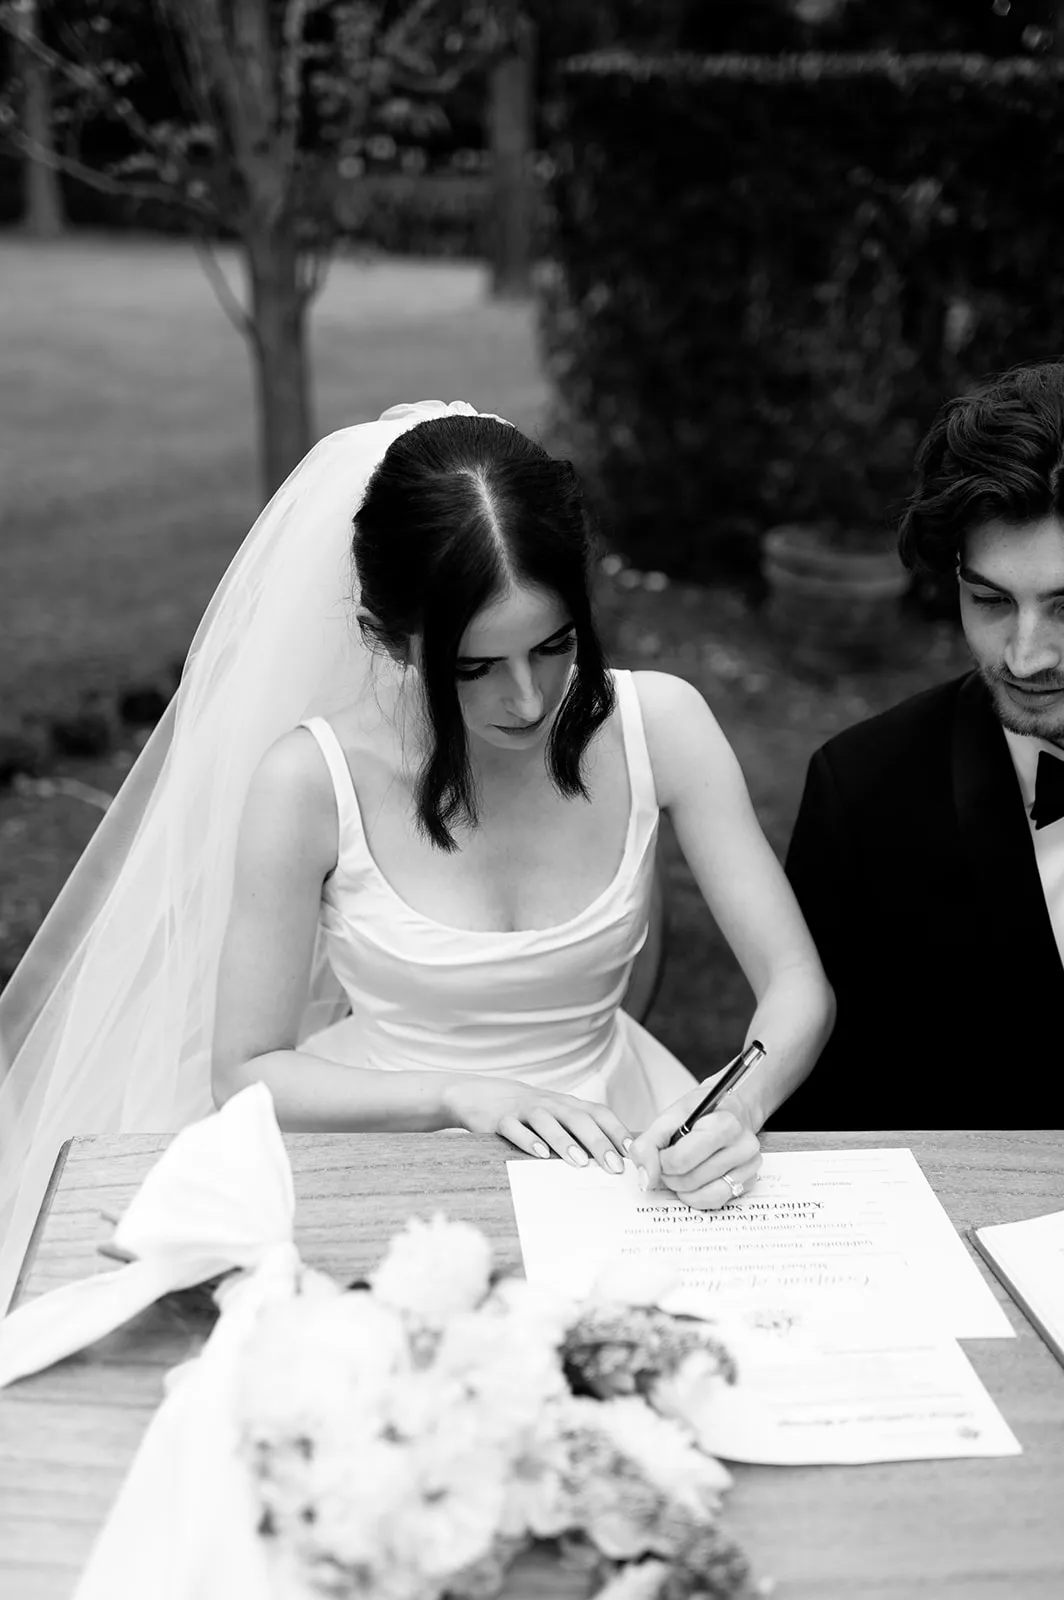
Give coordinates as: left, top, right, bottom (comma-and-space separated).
245, 221, 314, 502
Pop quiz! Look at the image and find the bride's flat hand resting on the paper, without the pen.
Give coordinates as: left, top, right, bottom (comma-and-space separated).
446, 1072, 630, 1173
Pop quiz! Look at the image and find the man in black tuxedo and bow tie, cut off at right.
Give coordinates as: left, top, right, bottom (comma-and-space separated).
771, 362, 1064, 1130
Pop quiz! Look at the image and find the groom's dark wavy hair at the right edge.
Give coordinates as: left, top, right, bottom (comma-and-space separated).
898, 360, 1064, 574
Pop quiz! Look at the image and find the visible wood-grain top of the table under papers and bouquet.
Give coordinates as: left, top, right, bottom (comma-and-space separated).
0, 1133, 1064, 1600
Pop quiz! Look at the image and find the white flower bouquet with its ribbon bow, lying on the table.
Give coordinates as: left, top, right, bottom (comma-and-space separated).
0, 1083, 760, 1600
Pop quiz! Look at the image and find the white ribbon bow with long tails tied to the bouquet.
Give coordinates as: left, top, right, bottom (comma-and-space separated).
0, 1083, 301, 1600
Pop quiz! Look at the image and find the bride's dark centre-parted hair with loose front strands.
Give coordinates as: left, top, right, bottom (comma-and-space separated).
352, 416, 614, 850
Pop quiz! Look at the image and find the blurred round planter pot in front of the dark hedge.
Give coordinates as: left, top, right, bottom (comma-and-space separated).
762, 523, 910, 675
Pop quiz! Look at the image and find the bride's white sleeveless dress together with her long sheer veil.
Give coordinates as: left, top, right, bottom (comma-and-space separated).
0, 400, 694, 1315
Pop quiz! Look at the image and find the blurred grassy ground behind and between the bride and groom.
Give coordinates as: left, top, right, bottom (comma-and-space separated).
0, 237, 965, 1075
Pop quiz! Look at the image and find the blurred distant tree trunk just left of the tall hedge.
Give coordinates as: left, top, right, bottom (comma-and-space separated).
488, 16, 536, 299
